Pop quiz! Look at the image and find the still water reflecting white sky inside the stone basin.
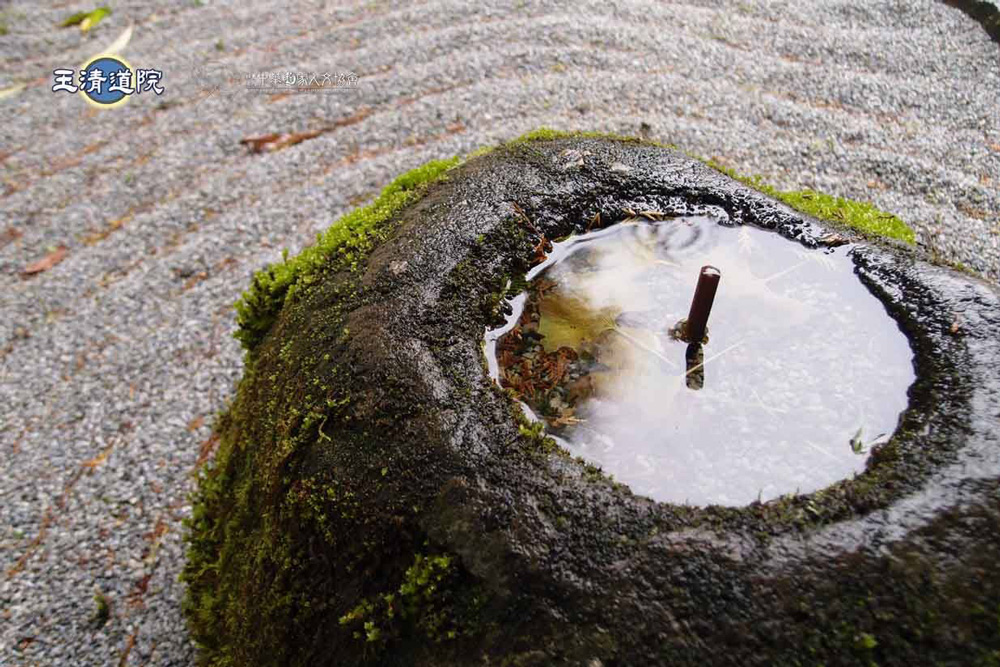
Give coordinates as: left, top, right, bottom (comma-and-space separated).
486, 216, 914, 505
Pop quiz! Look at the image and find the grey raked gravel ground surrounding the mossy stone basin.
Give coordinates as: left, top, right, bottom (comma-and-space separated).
0, 0, 1000, 665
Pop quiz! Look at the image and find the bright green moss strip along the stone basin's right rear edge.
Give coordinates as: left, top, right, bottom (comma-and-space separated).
704, 160, 916, 245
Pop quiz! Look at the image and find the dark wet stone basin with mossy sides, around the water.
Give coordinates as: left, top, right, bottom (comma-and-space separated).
184, 136, 1000, 666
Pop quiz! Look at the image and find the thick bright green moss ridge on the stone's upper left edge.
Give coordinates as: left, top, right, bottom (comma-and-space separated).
236, 157, 459, 350
